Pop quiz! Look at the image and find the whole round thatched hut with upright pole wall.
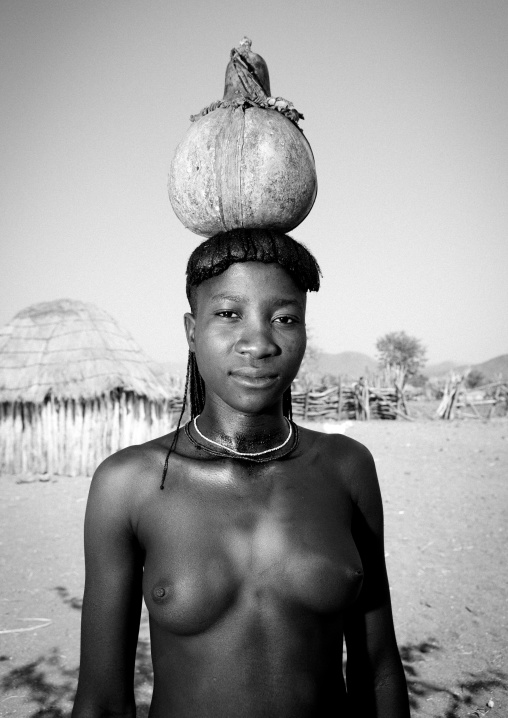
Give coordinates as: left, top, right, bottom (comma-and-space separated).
0, 299, 178, 476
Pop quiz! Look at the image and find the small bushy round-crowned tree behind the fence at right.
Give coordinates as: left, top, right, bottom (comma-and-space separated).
376, 332, 426, 389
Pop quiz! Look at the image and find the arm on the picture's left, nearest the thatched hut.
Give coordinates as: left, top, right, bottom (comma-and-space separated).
72, 449, 143, 718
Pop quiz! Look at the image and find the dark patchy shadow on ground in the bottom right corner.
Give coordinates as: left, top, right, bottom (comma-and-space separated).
399, 638, 508, 718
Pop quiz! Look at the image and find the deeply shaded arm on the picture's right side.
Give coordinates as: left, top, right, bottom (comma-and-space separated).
344, 446, 409, 718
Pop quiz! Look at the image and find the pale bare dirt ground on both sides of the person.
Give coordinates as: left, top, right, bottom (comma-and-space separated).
0, 418, 508, 718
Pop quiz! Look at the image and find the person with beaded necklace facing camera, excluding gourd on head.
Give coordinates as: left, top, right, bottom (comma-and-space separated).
73, 230, 409, 718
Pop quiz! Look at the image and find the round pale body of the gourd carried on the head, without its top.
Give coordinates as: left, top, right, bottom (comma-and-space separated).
168, 107, 317, 237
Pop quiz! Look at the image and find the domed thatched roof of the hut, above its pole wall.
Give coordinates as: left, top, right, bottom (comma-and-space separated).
0, 299, 168, 403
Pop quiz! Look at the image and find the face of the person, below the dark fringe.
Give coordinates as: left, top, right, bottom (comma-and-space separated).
185, 262, 306, 413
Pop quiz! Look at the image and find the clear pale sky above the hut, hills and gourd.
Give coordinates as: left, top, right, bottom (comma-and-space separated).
0, 0, 508, 363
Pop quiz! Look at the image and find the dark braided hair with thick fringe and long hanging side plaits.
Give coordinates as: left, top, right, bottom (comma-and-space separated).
160, 229, 321, 489
